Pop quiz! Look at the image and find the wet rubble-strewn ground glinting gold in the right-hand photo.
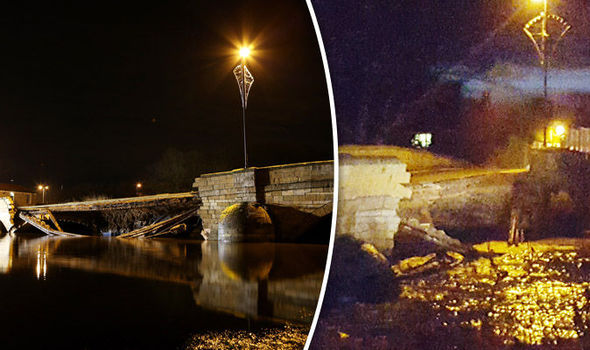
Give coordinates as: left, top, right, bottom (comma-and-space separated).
314, 239, 590, 349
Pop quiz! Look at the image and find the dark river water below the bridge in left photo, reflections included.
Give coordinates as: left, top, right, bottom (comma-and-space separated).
0, 235, 327, 349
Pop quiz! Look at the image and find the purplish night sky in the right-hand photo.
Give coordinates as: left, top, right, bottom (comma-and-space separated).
312, 0, 590, 144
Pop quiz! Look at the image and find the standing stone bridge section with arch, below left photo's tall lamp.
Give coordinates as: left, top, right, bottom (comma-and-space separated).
193, 161, 334, 241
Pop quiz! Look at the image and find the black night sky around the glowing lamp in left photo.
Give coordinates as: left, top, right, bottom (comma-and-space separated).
0, 0, 332, 194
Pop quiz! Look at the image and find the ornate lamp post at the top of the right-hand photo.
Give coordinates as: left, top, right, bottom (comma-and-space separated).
523, 0, 572, 147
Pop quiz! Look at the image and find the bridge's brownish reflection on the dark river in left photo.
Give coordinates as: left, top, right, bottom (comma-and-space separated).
0, 235, 327, 323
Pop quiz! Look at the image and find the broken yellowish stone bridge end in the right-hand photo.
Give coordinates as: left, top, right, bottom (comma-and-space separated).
336, 145, 527, 252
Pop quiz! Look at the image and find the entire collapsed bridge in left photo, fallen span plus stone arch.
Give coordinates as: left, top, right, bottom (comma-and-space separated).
0, 161, 334, 242
